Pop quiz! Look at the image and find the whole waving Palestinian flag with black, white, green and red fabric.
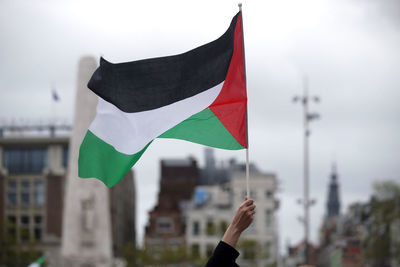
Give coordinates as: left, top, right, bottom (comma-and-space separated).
79, 12, 247, 187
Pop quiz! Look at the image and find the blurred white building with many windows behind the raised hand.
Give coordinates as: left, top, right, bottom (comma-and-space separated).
184, 161, 279, 266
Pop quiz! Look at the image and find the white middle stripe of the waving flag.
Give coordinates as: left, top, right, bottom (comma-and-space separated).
89, 82, 224, 154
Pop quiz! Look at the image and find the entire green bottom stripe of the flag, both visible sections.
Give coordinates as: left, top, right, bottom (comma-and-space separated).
78, 109, 244, 187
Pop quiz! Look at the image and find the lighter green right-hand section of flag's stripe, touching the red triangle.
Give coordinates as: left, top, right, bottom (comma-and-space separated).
159, 109, 244, 150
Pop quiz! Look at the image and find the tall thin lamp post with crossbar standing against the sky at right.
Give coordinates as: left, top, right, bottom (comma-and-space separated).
293, 77, 320, 264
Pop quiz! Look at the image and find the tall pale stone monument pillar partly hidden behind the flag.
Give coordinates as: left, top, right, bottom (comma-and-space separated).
59, 57, 113, 267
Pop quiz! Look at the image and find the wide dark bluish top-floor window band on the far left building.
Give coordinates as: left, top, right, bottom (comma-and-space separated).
3, 148, 47, 174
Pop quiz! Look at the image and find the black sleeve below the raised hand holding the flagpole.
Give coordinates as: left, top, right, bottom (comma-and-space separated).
205, 241, 239, 267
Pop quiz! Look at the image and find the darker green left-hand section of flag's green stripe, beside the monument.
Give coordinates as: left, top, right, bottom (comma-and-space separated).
78, 130, 151, 187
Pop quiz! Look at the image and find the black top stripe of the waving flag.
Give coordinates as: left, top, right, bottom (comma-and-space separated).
88, 14, 238, 112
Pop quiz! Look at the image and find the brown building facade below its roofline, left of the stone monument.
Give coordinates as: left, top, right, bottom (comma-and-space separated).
0, 137, 69, 247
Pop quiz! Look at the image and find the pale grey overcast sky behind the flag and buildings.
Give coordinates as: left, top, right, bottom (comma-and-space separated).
0, 0, 400, 255
